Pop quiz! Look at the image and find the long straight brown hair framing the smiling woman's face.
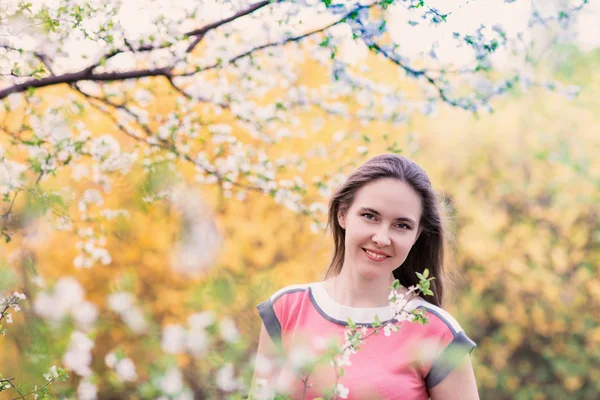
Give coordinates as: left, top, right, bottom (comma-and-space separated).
326, 154, 446, 307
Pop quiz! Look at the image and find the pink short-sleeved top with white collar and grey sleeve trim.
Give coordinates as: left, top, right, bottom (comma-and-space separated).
257, 282, 476, 400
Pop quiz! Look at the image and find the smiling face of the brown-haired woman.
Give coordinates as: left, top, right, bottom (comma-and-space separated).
338, 178, 422, 280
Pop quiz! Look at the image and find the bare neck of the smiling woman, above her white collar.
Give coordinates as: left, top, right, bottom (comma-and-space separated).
329, 269, 394, 308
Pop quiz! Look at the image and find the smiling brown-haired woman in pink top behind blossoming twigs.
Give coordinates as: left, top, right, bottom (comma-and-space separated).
253, 154, 479, 400
